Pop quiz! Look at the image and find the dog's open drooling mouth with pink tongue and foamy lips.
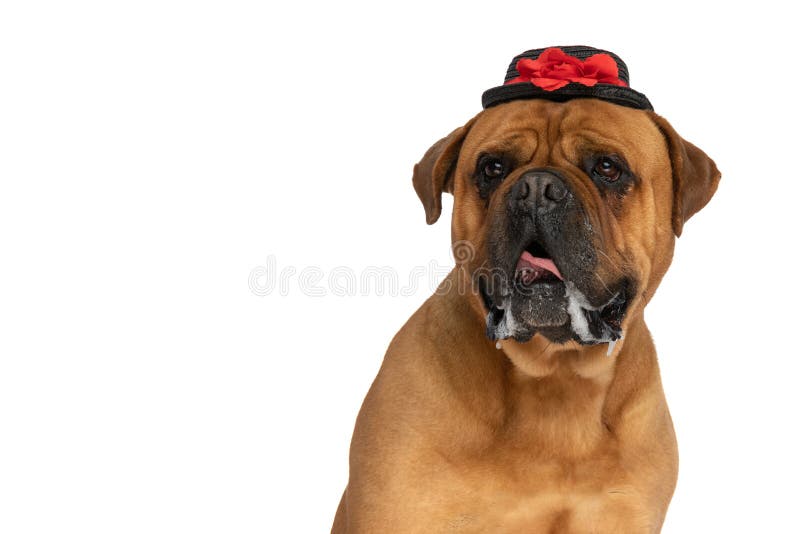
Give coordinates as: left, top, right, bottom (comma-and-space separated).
478, 240, 631, 345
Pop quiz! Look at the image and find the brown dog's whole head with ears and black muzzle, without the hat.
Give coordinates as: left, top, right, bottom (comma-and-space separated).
414, 99, 720, 344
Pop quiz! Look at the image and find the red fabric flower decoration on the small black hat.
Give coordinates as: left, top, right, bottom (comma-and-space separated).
506, 48, 628, 91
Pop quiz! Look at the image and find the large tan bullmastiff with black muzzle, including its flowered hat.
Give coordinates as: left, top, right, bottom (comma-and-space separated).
332, 47, 720, 534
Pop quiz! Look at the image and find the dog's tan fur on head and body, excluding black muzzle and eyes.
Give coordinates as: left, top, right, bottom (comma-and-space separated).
332, 100, 719, 534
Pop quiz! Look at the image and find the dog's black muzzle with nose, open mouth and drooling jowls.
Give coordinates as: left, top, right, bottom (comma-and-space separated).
478, 169, 629, 350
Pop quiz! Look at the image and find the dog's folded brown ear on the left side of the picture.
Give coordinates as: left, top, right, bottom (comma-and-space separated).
412, 119, 475, 224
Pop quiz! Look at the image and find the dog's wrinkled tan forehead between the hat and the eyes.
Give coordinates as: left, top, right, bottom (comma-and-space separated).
461, 98, 666, 168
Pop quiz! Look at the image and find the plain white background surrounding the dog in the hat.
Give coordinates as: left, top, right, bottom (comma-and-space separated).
0, 1, 800, 533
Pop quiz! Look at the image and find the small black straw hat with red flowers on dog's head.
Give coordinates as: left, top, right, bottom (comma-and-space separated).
482, 46, 653, 110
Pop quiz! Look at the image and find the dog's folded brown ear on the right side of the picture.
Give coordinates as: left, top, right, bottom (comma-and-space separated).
652, 113, 720, 237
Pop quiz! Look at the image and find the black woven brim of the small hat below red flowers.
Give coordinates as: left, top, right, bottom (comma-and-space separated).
481, 82, 653, 111
